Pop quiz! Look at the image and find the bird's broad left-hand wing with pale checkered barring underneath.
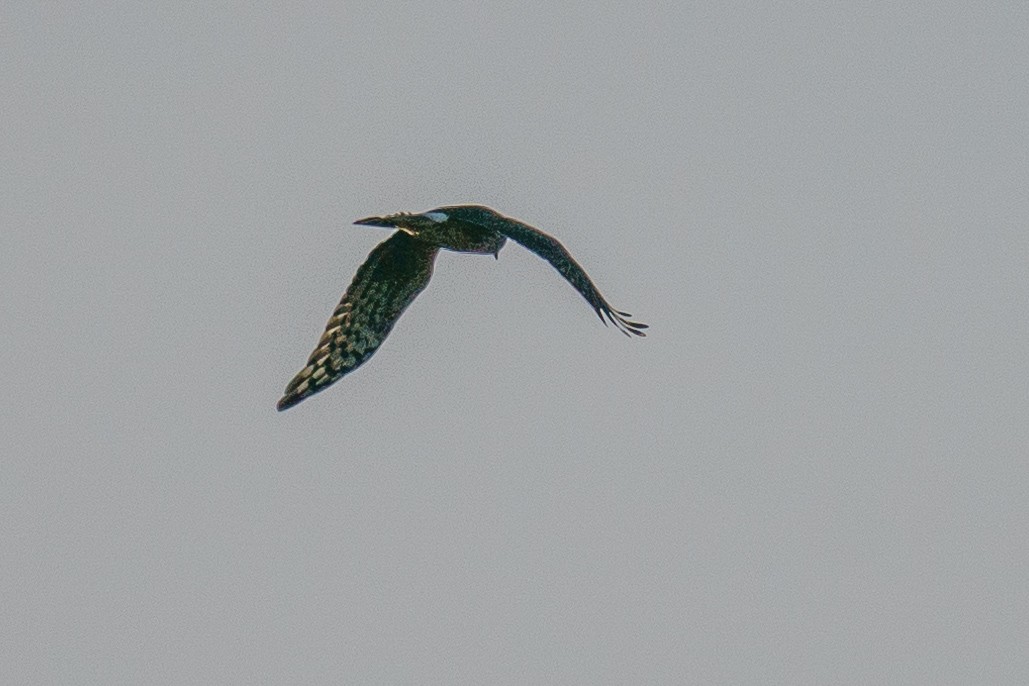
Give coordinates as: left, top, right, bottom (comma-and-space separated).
278, 231, 438, 411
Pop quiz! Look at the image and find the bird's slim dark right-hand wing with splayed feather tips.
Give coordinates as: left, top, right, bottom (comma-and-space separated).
441, 207, 647, 336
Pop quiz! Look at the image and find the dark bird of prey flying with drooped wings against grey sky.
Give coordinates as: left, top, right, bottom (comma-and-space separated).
277, 205, 647, 411
